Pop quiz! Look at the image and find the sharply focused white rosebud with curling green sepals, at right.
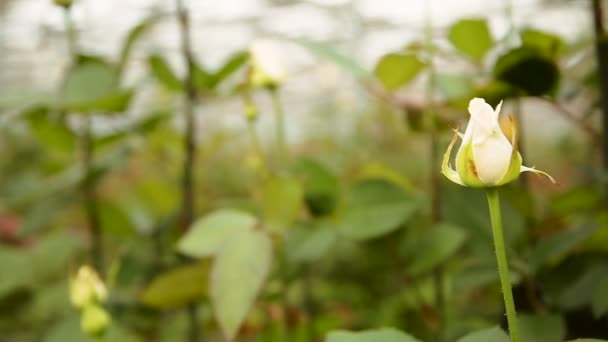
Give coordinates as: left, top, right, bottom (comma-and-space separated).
442, 98, 555, 188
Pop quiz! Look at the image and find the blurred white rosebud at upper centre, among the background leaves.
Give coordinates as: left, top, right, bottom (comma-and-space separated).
249, 39, 287, 87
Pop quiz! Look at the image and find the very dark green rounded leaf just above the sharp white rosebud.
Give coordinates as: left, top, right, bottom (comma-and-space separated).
494, 46, 560, 96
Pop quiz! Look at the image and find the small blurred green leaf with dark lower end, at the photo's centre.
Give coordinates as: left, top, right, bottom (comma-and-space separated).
293, 159, 339, 216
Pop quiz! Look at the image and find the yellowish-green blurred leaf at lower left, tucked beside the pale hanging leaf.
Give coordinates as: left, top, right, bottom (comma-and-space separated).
139, 262, 209, 309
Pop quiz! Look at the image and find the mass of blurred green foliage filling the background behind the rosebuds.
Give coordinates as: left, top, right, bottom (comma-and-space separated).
0, 4, 608, 342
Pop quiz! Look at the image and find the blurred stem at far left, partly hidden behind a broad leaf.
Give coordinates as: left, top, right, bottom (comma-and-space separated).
64, 6, 105, 275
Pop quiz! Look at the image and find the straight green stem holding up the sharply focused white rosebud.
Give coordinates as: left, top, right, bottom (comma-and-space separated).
486, 188, 519, 342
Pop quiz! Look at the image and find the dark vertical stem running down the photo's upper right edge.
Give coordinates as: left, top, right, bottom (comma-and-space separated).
591, 0, 608, 202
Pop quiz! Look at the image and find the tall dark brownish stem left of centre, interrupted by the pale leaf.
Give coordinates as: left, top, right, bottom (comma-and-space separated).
175, 0, 202, 342
